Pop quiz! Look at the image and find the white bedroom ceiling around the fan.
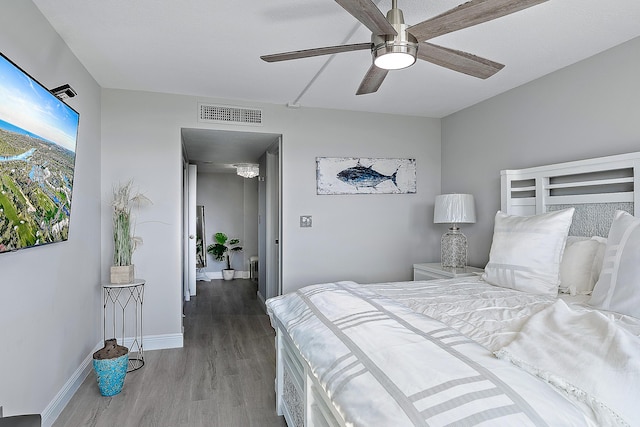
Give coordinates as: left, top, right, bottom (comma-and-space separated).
33, 0, 640, 164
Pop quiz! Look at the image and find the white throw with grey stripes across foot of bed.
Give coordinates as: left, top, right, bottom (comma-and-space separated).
267, 282, 594, 427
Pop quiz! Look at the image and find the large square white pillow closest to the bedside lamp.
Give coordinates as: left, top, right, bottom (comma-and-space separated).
482, 208, 575, 295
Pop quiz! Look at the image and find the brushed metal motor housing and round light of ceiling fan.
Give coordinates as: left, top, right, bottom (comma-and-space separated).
371, 8, 418, 70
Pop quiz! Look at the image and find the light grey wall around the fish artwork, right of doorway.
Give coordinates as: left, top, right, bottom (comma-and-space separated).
281, 109, 440, 292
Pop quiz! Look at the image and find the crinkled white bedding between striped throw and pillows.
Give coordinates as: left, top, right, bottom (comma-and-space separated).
368, 277, 640, 426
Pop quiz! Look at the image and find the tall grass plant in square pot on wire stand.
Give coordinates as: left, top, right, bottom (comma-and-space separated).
111, 181, 151, 283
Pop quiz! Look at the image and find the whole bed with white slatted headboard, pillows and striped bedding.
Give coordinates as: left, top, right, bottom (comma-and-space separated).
267, 153, 640, 427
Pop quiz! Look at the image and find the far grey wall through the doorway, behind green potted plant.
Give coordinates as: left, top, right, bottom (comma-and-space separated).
196, 173, 258, 273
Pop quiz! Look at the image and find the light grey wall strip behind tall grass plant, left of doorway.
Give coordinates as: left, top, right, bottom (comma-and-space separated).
101, 89, 185, 342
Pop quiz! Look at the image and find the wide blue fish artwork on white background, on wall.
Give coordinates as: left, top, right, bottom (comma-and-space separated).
316, 157, 416, 194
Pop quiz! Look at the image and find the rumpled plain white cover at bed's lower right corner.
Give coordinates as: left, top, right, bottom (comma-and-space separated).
496, 300, 640, 426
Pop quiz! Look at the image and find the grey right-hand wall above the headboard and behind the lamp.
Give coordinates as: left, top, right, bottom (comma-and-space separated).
442, 38, 640, 266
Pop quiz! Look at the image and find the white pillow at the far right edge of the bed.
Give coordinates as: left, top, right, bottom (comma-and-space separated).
589, 211, 640, 318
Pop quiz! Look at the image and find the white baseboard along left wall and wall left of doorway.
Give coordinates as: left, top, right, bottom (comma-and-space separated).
41, 334, 184, 427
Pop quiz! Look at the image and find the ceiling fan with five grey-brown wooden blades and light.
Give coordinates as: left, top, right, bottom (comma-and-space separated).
260, 0, 547, 95
